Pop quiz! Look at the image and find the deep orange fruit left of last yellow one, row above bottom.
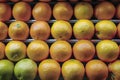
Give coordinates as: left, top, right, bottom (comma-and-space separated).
73, 40, 95, 62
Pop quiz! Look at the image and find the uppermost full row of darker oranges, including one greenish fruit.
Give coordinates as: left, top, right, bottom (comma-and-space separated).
0, 1, 120, 21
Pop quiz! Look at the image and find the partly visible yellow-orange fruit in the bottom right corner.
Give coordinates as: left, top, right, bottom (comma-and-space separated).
108, 60, 120, 80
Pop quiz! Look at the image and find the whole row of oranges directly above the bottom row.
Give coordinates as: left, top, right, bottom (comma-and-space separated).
0, 40, 120, 62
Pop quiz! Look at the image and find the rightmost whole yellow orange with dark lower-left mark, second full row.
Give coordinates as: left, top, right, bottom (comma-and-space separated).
95, 20, 117, 39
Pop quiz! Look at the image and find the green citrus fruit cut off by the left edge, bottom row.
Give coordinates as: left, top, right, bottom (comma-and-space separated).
0, 59, 14, 80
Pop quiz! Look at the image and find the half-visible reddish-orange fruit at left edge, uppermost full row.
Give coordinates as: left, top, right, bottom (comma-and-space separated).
0, 3, 11, 21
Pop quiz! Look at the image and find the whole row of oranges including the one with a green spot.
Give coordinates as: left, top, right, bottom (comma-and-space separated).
0, 19, 120, 40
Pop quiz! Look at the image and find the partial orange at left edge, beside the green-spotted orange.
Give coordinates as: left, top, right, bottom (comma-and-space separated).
0, 22, 8, 40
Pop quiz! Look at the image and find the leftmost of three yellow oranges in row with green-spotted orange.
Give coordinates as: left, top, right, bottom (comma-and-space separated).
51, 20, 72, 40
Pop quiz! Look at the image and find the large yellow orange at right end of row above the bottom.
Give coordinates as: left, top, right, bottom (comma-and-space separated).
96, 40, 119, 62
